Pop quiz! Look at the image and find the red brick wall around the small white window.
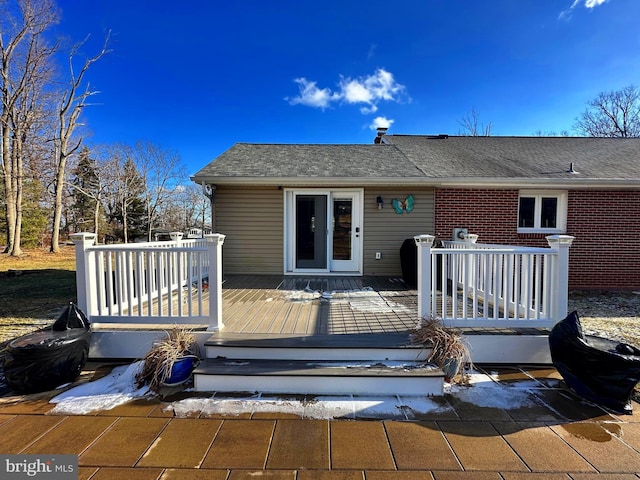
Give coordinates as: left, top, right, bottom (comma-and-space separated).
435, 188, 640, 290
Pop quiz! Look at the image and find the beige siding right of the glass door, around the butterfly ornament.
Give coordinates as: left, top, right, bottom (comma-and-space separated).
363, 187, 435, 276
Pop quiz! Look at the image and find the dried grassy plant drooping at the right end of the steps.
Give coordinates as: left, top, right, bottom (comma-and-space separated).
411, 318, 471, 380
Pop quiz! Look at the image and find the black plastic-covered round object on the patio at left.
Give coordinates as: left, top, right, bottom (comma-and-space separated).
4, 304, 91, 393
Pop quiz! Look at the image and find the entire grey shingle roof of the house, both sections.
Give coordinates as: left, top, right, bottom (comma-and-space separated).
193, 135, 640, 186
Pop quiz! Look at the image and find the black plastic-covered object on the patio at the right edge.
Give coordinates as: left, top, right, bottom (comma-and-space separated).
549, 312, 640, 413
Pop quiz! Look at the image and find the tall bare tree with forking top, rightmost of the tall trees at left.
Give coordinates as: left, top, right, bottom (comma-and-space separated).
51, 33, 109, 252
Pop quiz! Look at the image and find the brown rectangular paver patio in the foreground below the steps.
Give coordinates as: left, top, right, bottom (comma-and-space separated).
0, 367, 640, 480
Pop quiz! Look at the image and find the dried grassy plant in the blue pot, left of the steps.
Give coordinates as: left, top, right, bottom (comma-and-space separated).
136, 327, 198, 393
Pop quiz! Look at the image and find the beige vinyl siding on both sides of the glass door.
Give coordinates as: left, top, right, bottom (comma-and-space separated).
215, 186, 434, 276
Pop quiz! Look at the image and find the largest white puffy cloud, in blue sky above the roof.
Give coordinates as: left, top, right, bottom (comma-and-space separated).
285, 68, 406, 115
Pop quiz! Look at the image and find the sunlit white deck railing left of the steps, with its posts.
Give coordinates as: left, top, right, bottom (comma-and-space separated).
72, 233, 225, 331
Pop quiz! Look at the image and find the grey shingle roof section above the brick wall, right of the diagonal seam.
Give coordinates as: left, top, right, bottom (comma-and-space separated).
386, 135, 640, 179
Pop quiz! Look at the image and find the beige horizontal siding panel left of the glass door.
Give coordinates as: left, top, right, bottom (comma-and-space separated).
214, 186, 284, 275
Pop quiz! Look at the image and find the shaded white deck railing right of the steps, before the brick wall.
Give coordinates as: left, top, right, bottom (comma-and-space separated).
415, 235, 573, 327
